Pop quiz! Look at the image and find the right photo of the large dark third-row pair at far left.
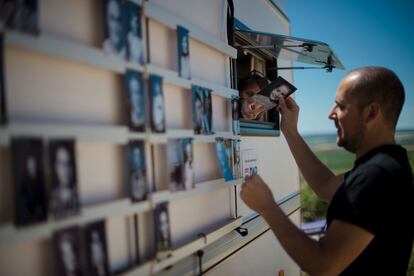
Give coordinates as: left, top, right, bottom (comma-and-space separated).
49, 140, 79, 218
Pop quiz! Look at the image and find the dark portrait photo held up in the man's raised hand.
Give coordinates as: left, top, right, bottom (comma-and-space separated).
251, 77, 296, 110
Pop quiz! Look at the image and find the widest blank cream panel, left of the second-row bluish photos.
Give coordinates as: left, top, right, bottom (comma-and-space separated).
5, 48, 125, 124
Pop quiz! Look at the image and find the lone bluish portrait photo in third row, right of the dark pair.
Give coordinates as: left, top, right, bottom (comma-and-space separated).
128, 141, 148, 202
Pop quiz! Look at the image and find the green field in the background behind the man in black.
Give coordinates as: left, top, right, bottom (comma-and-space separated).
300, 131, 414, 275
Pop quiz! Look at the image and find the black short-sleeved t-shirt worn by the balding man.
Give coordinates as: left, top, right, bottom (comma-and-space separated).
327, 145, 414, 275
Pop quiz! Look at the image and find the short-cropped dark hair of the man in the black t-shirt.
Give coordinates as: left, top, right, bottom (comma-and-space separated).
348, 67, 405, 127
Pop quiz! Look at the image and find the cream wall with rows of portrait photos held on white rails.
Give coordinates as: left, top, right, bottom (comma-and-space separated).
0, 0, 251, 275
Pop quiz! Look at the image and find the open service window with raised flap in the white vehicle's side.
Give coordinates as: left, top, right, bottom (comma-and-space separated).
232, 25, 345, 136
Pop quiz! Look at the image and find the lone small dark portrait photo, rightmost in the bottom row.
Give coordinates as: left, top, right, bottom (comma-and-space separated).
154, 202, 171, 253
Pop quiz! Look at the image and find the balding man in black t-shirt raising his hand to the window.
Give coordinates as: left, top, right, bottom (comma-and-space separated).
240, 67, 414, 275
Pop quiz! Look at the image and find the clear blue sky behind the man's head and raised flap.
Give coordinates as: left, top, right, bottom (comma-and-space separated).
284, 0, 414, 134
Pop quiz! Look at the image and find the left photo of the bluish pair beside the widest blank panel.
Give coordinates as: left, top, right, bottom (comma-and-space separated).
125, 70, 146, 132
